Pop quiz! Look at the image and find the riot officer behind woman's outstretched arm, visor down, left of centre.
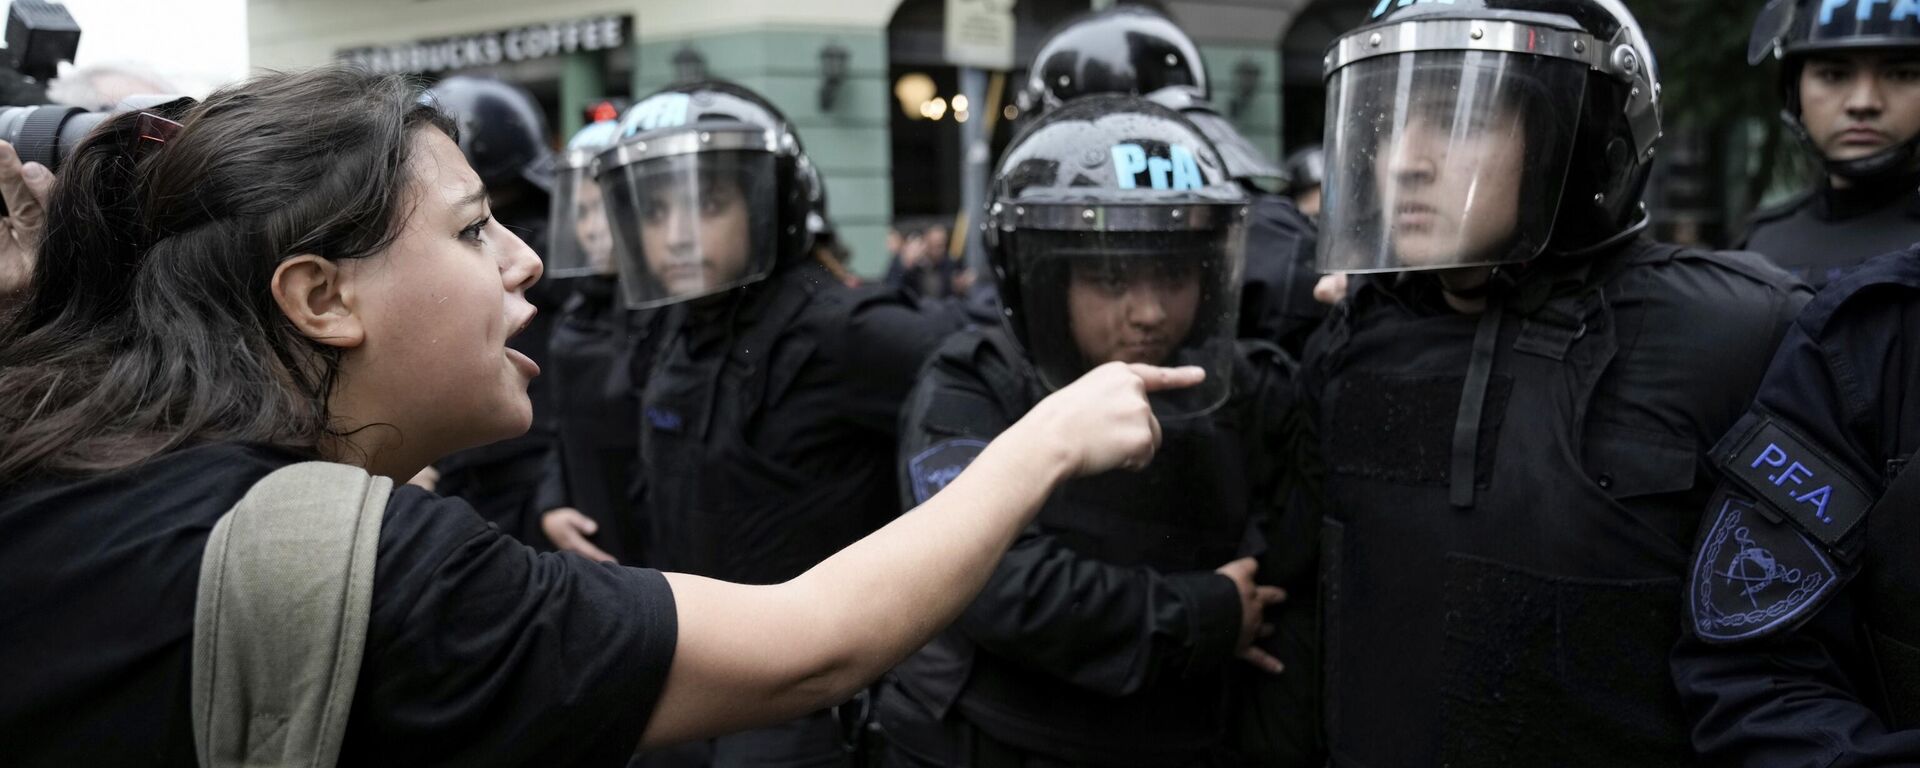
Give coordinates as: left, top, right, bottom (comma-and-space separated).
599, 83, 952, 766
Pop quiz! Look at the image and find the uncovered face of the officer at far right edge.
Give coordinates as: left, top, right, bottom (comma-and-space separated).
1799, 52, 1920, 161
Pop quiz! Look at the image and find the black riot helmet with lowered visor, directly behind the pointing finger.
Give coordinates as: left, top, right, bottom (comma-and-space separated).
985, 96, 1248, 417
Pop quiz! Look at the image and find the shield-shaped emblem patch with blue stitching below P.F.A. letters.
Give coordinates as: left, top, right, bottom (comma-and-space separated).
1688, 493, 1841, 643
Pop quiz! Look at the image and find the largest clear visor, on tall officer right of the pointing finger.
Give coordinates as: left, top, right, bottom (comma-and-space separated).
1319, 50, 1586, 273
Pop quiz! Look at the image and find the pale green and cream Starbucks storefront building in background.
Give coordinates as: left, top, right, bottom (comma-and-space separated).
248, 0, 1334, 276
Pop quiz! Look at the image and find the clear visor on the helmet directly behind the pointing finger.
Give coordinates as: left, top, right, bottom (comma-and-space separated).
1004, 205, 1246, 419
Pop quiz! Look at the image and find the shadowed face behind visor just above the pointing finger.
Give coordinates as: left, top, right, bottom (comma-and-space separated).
1068, 259, 1200, 365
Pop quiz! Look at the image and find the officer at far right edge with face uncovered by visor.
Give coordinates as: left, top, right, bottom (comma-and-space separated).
1741, 0, 1920, 288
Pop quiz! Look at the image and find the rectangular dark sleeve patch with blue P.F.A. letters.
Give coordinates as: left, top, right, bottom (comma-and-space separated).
1716, 419, 1874, 551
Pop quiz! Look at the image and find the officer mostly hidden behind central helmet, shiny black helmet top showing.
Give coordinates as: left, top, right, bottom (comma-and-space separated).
1020, 6, 1327, 353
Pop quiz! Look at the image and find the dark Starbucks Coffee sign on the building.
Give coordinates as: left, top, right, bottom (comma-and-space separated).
334, 15, 625, 73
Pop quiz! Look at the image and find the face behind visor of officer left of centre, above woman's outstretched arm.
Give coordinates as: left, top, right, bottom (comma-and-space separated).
639, 175, 753, 296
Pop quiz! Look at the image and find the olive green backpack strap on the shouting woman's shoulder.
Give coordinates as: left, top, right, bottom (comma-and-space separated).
192, 461, 394, 768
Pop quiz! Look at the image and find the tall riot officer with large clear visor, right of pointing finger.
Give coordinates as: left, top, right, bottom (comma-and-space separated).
1300, 0, 1807, 766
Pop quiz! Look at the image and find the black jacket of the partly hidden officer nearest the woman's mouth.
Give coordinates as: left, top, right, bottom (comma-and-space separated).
536, 276, 662, 564
